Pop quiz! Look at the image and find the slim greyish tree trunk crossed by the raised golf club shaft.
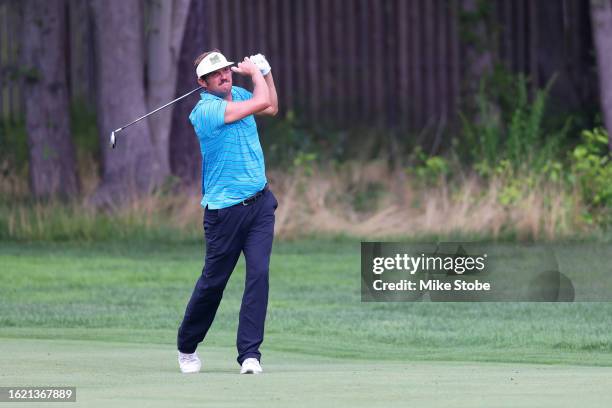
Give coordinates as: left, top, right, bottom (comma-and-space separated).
147, 0, 190, 179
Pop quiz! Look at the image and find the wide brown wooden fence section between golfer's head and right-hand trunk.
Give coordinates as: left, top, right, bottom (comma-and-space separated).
205, 0, 460, 127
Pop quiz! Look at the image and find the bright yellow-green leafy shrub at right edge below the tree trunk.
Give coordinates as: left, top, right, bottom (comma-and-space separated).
572, 127, 612, 223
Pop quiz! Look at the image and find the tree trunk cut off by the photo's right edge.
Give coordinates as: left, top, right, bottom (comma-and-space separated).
591, 0, 612, 152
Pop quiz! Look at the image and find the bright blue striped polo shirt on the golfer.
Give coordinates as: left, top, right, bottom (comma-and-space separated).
189, 86, 267, 210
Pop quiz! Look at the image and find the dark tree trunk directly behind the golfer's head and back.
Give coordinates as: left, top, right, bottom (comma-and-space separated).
170, 1, 203, 185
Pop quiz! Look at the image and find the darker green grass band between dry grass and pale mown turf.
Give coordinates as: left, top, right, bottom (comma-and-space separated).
0, 239, 612, 366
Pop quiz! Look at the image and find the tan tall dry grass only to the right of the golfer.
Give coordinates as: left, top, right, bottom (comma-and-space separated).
270, 163, 586, 239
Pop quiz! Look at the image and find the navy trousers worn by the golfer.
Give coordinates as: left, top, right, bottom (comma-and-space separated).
177, 190, 278, 364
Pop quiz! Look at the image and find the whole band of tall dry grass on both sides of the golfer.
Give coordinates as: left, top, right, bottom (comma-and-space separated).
0, 162, 587, 240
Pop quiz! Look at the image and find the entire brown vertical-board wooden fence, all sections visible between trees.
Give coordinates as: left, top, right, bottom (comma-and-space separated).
0, 0, 592, 130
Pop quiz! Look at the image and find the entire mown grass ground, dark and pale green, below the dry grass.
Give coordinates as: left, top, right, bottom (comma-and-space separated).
0, 239, 612, 407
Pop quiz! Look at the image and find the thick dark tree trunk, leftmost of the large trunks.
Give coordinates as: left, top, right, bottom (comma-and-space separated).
22, 0, 79, 197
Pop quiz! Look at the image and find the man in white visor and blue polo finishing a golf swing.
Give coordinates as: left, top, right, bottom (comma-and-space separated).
177, 50, 278, 374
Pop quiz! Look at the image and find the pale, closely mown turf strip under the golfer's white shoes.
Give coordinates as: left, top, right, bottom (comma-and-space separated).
0, 339, 612, 408
